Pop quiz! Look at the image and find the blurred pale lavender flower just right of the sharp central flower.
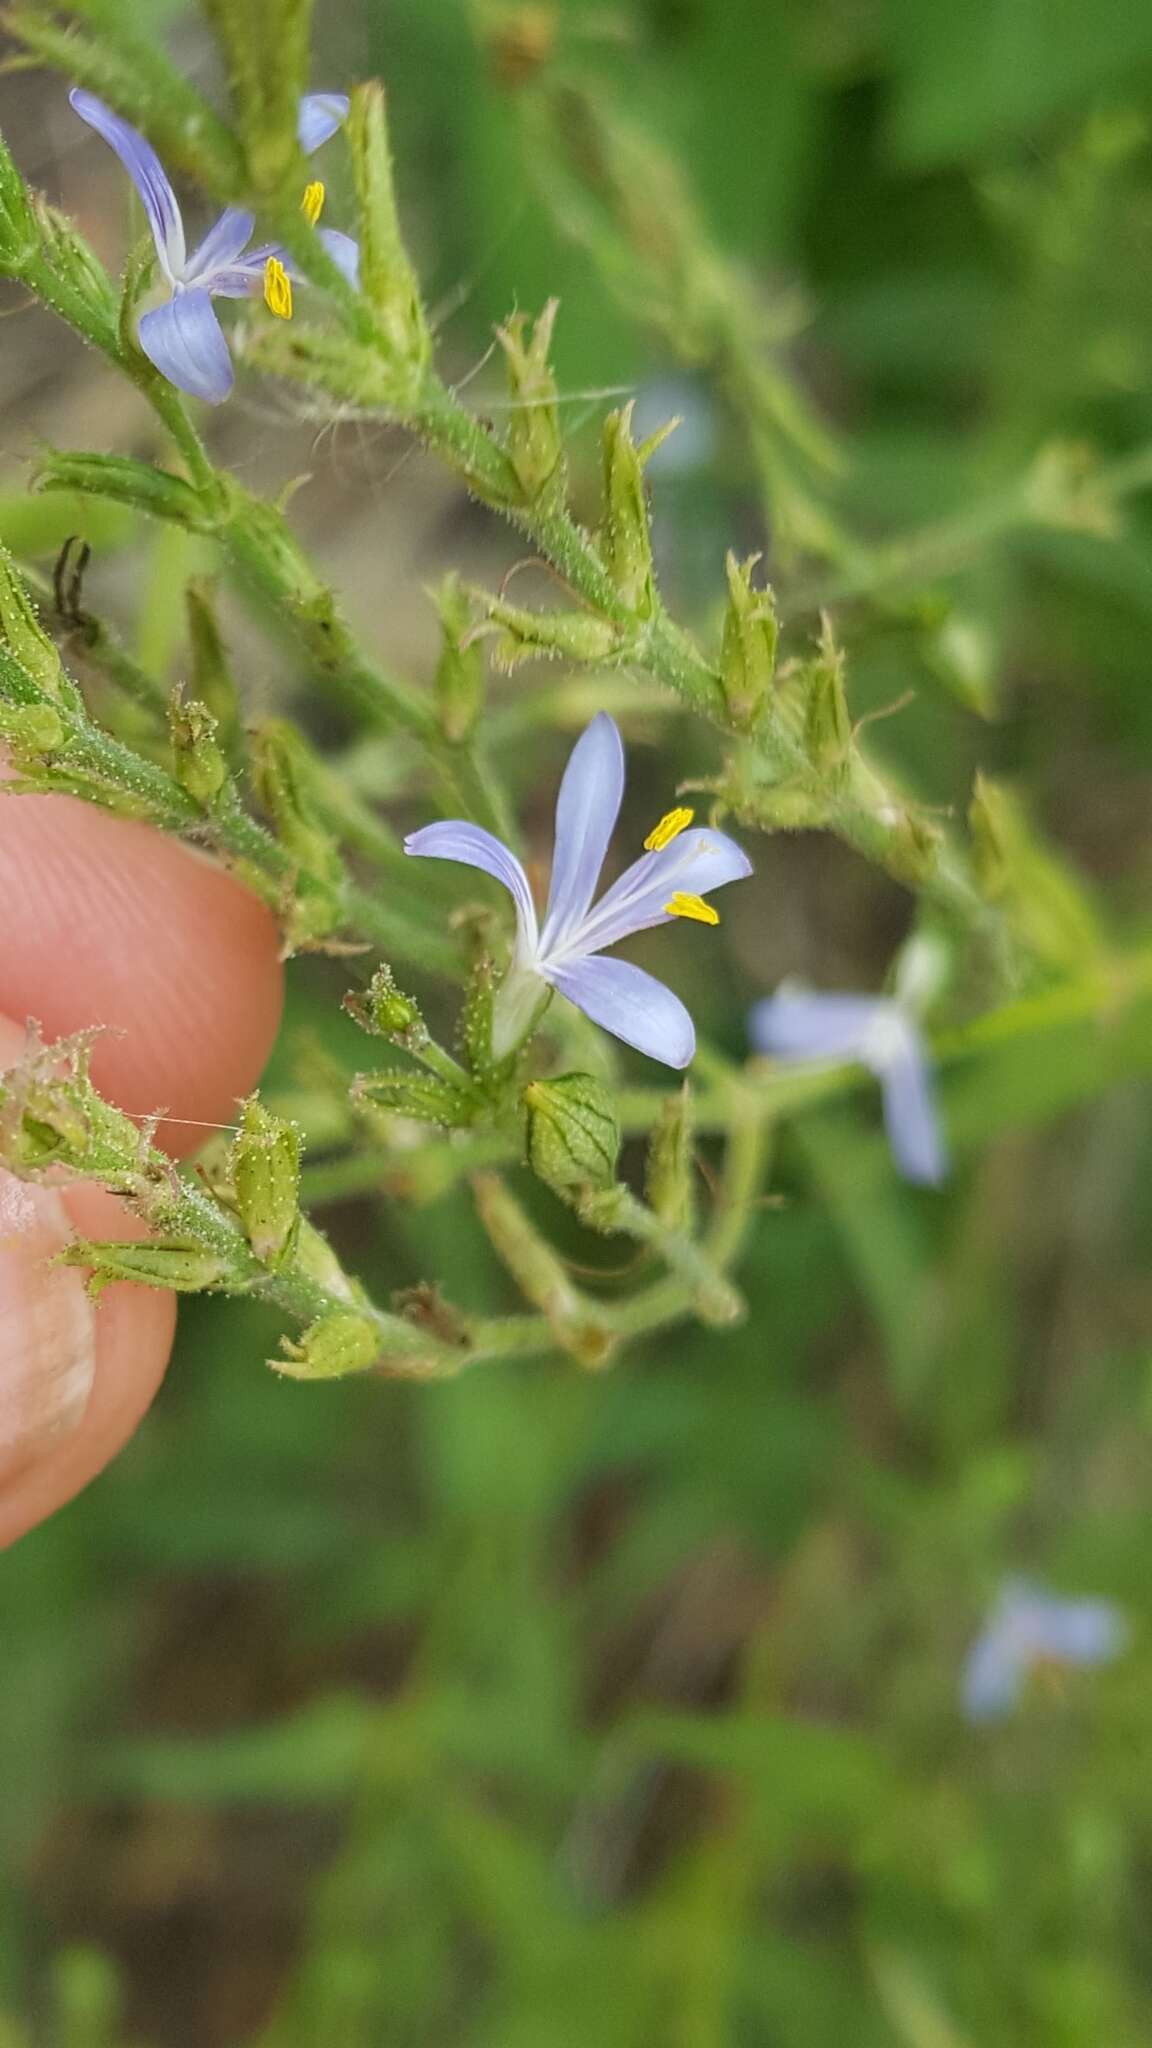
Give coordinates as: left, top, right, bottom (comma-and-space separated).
748, 983, 947, 1188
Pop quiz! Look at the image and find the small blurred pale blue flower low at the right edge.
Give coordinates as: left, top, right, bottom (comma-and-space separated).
961, 1579, 1127, 1722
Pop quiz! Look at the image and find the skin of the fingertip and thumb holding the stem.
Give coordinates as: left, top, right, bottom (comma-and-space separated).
0, 797, 283, 1546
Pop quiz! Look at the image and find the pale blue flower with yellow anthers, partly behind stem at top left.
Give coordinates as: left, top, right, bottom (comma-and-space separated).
70, 86, 359, 406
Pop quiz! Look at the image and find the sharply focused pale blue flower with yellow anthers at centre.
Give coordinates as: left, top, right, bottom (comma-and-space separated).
404, 711, 752, 1067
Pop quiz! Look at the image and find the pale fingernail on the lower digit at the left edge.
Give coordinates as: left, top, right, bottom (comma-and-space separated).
0, 1169, 96, 1479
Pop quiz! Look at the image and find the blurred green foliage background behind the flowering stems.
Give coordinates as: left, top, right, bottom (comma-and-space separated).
0, 0, 1152, 2048
